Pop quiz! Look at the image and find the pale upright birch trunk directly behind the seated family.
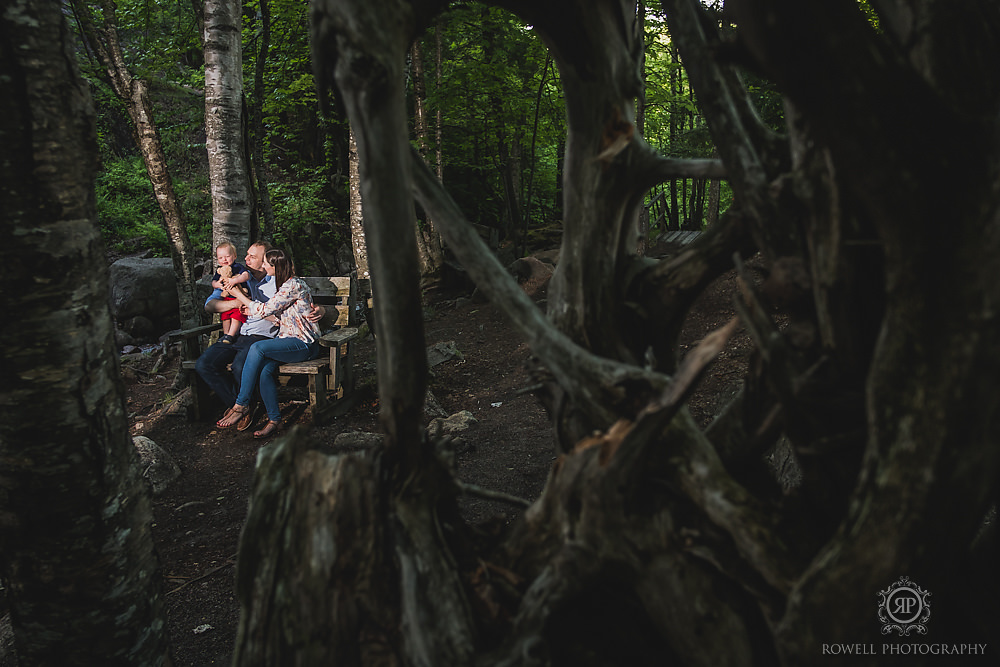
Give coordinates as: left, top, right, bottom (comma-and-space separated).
205, 0, 253, 252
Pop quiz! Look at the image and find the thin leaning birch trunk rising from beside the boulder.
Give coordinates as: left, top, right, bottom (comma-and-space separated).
73, 0, 202, 327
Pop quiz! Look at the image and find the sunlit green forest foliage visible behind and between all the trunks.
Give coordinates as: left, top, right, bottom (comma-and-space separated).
80, 0, 780, 256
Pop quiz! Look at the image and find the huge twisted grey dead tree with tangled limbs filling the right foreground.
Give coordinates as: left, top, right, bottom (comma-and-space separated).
237, 0, 1000, 666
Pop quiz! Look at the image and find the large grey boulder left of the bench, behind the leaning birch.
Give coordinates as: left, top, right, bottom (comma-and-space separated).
108, 257, 180, 339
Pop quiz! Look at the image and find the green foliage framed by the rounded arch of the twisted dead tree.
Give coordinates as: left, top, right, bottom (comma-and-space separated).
422, 4, 566, 232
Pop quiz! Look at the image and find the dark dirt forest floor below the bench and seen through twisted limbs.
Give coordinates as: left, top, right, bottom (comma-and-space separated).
0, 260, 751, 667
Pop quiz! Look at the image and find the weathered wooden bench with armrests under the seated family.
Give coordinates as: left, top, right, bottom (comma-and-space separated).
167, 276, 358, 424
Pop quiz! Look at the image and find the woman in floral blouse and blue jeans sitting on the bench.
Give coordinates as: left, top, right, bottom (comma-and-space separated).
217, 248, 320, 438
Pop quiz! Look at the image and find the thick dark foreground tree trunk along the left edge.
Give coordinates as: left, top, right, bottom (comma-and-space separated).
0, 2, 171, 667
